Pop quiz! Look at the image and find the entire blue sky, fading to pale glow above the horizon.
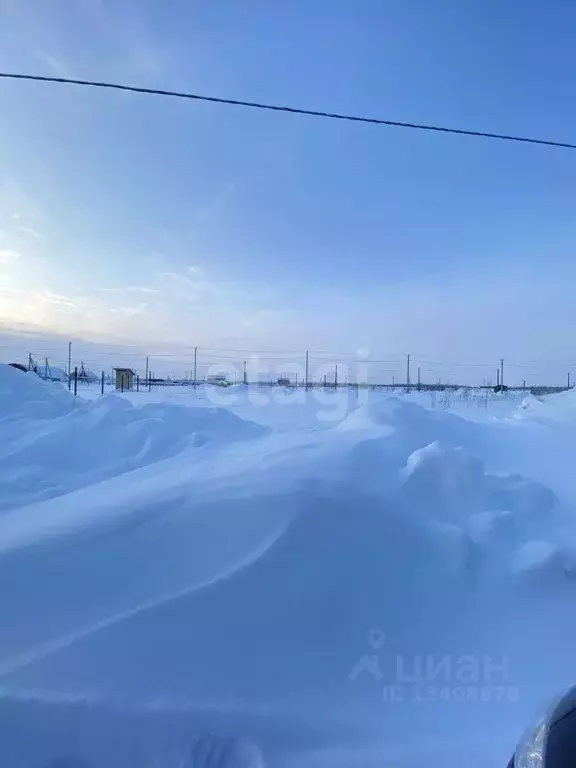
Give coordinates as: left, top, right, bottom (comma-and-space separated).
0, 0, 576, 384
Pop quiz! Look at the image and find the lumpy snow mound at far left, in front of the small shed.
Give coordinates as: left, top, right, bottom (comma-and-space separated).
0, 366, 269, 510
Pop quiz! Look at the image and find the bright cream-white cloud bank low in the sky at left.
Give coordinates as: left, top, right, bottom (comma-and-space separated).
0, 256, 286, 352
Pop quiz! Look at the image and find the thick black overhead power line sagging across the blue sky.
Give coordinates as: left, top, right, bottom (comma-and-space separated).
0, 72, 576, 149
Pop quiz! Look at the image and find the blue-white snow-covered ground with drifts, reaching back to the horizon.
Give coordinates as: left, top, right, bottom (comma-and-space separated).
0, 366, 576, 768
